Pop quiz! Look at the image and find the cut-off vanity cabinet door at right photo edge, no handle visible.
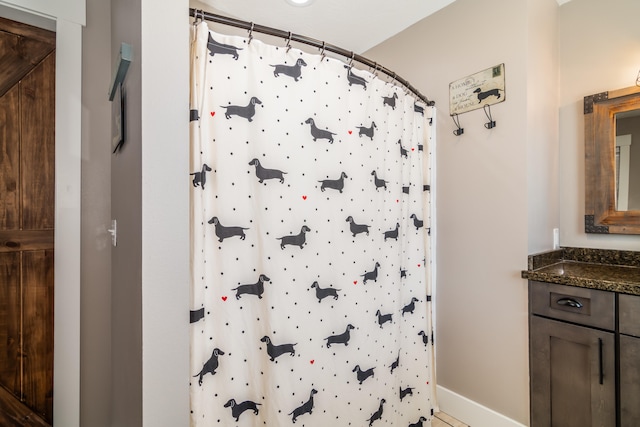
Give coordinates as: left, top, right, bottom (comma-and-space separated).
620, 335, 640, 427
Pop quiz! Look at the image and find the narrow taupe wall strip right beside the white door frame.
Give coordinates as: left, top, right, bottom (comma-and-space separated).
80, 0, 111, 427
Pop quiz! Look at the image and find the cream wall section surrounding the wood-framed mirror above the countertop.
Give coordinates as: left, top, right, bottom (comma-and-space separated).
559, 0, 640, 250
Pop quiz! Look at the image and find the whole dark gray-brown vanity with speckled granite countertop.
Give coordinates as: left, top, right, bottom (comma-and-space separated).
522, 247, 640, 427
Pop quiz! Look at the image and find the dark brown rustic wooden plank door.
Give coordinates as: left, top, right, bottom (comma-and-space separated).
0, 18, 55, 422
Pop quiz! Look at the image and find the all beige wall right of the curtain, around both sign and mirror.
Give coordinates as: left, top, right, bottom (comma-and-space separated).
366, 0, 640, 424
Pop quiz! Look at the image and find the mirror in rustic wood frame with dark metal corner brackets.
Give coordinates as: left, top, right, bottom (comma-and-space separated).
584, 86, 640, 234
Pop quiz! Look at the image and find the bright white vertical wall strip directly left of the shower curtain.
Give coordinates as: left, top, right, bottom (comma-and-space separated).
141, 0, 193, 427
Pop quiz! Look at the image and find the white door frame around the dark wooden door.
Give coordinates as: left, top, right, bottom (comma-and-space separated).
0, 0, 85, 427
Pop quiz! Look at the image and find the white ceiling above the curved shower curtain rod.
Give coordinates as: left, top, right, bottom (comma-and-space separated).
200, 0, 455, 54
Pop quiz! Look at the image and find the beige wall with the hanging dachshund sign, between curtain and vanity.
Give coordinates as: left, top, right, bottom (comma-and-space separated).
365, 0, 559, 425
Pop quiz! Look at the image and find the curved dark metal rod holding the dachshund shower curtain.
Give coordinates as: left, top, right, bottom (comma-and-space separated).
189, 8, 435, 106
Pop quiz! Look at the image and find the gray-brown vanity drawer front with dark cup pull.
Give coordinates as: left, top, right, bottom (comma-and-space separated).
529, 281, 615, 331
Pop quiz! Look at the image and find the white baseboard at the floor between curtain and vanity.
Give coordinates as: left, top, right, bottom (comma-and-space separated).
436, 386, 525, 427
